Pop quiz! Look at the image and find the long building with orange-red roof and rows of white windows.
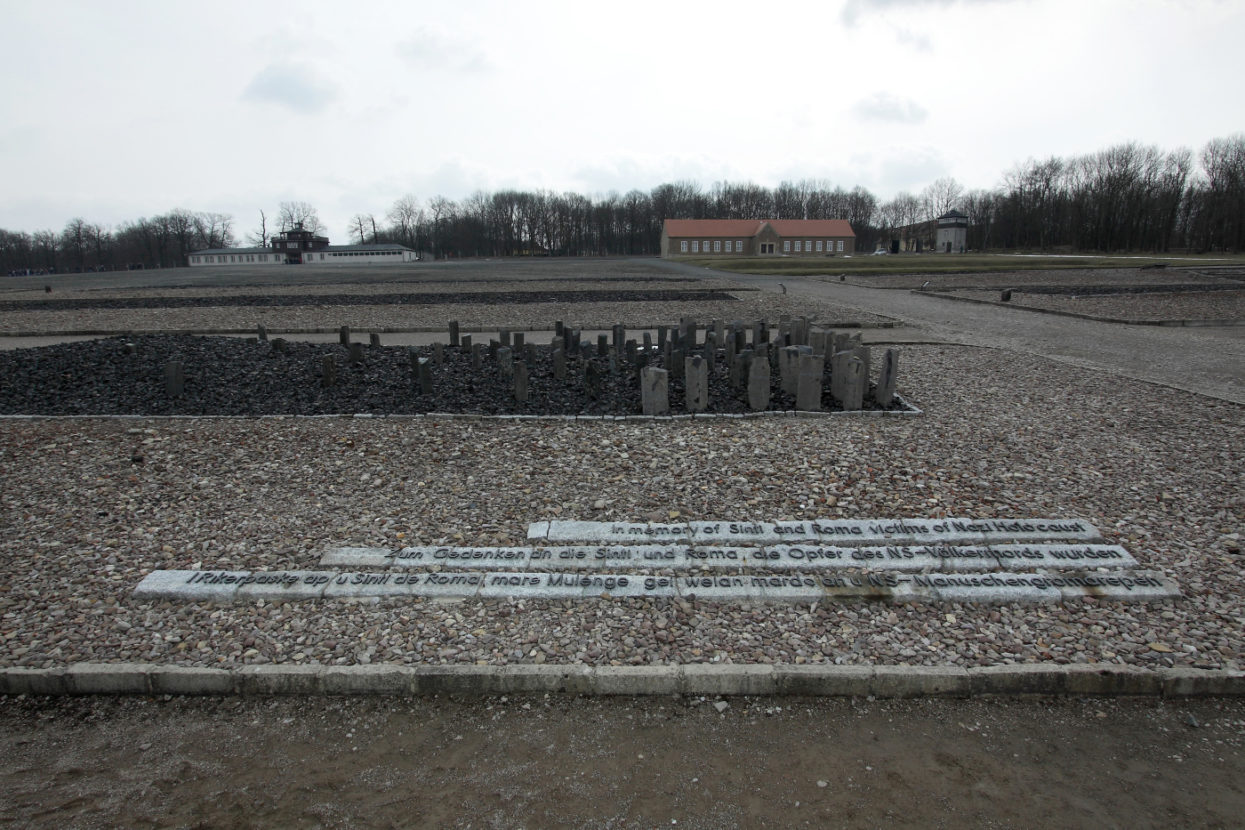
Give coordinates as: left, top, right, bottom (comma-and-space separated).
661, 219, 855, 256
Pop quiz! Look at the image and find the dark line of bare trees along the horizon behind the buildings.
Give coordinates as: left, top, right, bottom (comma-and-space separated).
0, 133, 1245, 273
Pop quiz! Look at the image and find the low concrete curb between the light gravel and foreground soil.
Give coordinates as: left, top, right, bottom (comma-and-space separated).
0, 663, 1245, 698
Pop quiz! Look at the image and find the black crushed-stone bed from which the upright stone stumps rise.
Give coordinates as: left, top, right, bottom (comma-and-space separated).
0, 335, 905, 416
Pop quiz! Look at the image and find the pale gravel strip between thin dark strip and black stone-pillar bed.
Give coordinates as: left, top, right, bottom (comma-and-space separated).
0, 294, 893, 335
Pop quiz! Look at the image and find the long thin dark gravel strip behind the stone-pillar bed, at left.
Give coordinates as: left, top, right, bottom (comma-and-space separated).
0, 290, 736, 311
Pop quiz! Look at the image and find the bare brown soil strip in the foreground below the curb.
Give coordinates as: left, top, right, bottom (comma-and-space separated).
0, 697, 1245, 830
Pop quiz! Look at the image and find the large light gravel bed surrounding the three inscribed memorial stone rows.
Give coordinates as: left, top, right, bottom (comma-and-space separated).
0, 346, 1245, 668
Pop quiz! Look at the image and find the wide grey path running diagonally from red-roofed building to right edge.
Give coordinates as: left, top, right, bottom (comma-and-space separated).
666, 257, 1245, 403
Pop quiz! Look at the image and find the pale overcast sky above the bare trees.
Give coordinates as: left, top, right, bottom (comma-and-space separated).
0, 0, 1245, 241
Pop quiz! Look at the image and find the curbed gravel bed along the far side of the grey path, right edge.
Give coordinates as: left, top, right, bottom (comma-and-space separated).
950, 289, 1245, 322
